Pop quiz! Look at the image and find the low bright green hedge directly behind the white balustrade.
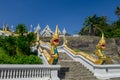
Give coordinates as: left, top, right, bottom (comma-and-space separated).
0, 47, 42, 64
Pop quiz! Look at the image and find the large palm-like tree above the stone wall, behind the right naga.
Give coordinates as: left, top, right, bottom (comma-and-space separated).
79, 15, 108, 35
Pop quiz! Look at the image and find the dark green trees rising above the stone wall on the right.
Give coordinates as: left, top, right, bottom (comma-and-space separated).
79, 6, 120, 38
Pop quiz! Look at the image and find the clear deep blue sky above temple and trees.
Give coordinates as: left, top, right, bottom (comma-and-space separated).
0, 0, 120, 34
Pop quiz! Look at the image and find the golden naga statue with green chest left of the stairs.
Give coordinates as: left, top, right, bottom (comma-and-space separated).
40, 26, 59, 65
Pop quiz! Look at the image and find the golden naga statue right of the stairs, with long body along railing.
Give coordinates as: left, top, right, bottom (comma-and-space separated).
63, 30, 113, 64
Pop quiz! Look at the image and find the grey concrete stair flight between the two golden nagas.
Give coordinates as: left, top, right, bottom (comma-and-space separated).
58, 53, 98, 80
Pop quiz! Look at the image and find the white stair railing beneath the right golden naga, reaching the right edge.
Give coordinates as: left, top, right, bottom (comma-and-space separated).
58, 46, 120, 80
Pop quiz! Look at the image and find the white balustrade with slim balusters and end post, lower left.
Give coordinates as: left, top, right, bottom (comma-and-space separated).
0, 64, 60, 80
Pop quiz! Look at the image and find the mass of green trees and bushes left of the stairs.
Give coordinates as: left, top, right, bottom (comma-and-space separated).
0, 24, 42, 64
